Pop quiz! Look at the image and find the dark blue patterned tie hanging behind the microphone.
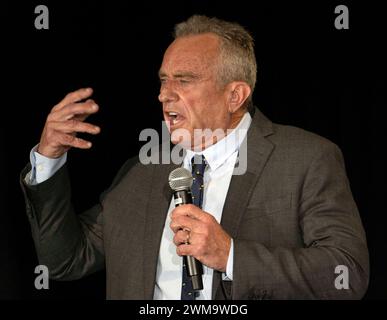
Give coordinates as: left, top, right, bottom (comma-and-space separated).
181, 155, 207, 300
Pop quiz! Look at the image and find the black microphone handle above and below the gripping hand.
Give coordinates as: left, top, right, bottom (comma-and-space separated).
173, 190, 203, 290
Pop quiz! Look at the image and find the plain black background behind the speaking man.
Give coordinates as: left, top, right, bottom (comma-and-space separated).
0, 0, 387, 299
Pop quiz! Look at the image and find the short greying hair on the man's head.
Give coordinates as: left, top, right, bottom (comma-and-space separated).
173, 15, 257, 111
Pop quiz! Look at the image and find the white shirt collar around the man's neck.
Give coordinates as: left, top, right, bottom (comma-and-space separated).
184, 112, 251, 170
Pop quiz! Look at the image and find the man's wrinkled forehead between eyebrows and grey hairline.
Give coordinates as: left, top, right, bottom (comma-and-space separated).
160, 34, 219, 74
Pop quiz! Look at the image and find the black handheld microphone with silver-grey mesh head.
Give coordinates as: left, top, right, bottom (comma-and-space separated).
168, 168, 203, 290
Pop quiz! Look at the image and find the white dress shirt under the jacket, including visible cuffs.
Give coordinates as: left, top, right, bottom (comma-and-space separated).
25, 112, 251, 300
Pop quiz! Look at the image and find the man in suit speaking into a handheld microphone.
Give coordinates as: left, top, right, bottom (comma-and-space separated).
22, 16, 369, 299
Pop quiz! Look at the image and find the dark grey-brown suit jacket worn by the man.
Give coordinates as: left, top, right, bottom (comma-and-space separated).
21, 110, 369, 299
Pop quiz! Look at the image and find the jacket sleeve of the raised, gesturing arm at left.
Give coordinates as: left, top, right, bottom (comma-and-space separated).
20, 158, 137, 280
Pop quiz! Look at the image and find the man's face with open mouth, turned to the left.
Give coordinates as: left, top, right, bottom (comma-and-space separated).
159, 34, 230, 146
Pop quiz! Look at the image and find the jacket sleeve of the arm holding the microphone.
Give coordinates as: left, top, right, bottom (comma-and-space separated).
232, 144, 369, 299
